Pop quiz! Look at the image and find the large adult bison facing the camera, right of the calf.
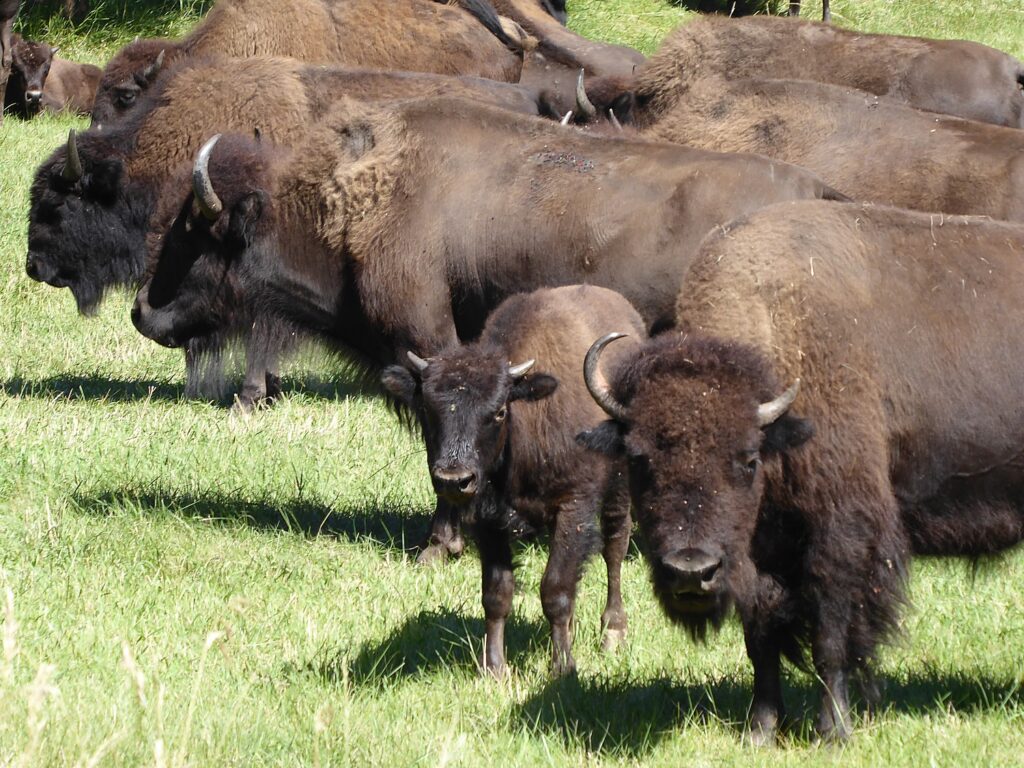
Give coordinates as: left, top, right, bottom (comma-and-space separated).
581, 202, 1024, 741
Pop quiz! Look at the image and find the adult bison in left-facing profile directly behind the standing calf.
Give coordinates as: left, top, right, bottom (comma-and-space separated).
132, 99, 841, 558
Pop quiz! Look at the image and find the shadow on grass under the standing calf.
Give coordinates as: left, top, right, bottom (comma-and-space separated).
298, 601, 548, 689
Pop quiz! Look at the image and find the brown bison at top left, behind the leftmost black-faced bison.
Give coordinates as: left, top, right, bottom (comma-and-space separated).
93, 0, 522, 125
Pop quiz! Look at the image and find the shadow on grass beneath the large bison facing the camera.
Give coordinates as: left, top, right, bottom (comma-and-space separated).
514, 670, 1024, 759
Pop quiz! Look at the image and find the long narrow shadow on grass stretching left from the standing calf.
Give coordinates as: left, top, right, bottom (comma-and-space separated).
71, 488, 430, 554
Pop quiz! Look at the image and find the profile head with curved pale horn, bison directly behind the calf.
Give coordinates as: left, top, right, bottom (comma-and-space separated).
131, 135, 269, 346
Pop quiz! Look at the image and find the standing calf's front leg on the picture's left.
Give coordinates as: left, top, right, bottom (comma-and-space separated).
477, 523, 515, 677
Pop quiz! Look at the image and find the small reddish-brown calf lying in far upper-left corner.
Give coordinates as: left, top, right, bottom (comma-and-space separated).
4, 35, 102, 118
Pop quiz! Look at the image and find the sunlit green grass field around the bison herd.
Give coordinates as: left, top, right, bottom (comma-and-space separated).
0, 0, 1024, 766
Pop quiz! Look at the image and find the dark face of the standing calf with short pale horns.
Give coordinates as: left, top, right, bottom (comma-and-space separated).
382, 347, 558, 504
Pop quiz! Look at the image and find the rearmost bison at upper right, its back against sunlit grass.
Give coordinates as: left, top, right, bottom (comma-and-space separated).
577, 16, 1024, 128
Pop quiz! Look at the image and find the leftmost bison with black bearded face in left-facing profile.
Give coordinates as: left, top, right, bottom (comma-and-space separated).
26, 58, 537, 410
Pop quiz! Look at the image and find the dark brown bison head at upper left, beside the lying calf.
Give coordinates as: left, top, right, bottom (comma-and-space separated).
92, 40, 180, 128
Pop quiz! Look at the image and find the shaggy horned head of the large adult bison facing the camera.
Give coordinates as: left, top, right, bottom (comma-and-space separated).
579, 334, 813, 638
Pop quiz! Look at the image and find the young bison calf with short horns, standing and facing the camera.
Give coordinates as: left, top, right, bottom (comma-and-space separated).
382, 286, 645, 675
